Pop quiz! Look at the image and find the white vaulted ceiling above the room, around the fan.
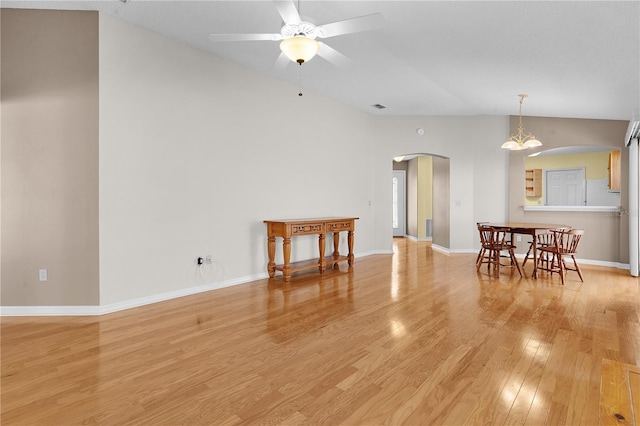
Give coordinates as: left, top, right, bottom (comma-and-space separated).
2, 0, 640, 120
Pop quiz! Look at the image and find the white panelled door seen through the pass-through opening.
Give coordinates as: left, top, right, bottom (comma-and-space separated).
545, 168, 587, 206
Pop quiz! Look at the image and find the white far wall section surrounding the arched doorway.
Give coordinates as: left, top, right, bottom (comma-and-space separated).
375, 116, 509, 252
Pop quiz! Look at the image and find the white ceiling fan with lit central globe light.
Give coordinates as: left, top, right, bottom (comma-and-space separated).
209, 0, 387, 68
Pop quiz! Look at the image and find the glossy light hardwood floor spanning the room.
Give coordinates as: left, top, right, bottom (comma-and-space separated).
1, 239, 640, 426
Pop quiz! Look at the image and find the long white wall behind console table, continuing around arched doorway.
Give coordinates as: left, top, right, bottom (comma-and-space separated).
100, 15, 508, 305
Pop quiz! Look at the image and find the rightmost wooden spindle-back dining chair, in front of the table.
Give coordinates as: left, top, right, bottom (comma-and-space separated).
538, 229, 584, 284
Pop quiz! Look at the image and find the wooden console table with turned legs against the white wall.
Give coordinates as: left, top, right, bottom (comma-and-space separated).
264, 217, 358, 282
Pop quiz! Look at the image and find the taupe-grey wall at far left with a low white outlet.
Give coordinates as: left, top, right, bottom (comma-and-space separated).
0, 9, 100, 306
